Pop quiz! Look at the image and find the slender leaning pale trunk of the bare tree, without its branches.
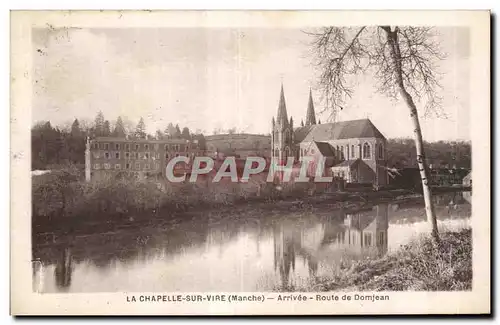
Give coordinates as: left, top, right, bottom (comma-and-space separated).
382, 26, 439, 243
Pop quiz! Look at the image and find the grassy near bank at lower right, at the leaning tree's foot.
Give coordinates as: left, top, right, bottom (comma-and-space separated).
309, 229, 472, 291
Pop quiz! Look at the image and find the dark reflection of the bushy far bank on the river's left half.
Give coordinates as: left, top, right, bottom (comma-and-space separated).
33, 212, 276, 274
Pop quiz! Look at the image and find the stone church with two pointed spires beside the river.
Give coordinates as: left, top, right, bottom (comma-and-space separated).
271, 85, 389, 187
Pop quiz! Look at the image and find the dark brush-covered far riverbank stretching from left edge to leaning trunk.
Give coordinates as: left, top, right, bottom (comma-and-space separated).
32, 167, 468, 235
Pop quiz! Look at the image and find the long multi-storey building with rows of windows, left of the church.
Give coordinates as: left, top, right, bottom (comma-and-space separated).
85, 137, 204, 180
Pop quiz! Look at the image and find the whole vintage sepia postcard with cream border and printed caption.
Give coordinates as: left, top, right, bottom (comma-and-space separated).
10, 11, 491, 315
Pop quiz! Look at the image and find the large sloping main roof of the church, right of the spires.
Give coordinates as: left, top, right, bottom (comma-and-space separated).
294, 119, 385, 142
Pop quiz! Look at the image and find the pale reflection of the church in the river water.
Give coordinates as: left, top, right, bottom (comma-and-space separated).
274, 204, 389, 288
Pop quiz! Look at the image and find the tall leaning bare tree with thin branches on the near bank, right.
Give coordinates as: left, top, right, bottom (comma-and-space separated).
308, 26, 444, 243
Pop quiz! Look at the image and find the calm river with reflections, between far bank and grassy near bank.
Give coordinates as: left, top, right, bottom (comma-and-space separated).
33, 192, 471, 293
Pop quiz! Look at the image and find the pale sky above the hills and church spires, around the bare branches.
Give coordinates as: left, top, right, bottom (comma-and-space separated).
32, 27, 470, 141
